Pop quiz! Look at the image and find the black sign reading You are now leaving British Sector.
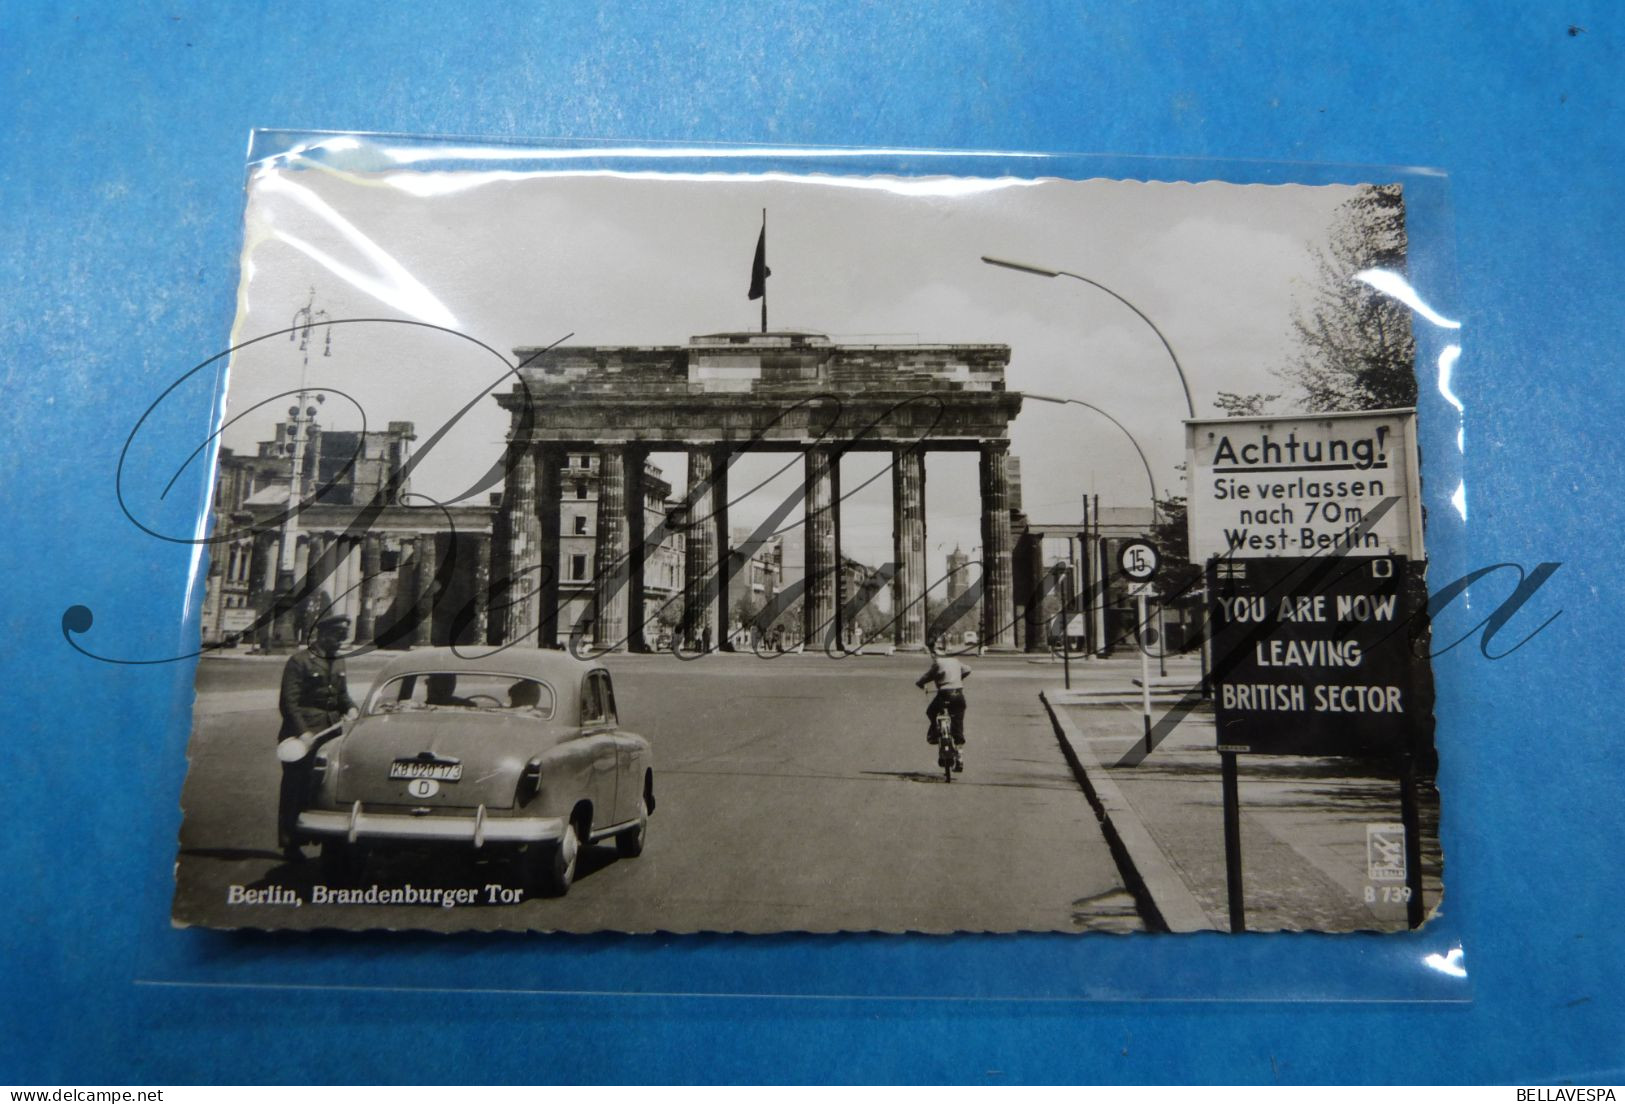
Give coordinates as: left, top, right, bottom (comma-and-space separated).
1207, 556, 1433, 758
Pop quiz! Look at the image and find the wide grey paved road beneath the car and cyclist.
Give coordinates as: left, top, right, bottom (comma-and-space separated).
176, 655, 1139, 932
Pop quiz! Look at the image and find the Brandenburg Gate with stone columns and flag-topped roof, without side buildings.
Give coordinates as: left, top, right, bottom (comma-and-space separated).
491, 333, 1021, 649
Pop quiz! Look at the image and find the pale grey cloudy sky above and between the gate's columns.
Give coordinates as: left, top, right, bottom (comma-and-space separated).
212, 161, 1355, 567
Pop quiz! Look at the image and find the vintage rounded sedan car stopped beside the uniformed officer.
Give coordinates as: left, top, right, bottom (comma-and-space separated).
297, 647, 655, 894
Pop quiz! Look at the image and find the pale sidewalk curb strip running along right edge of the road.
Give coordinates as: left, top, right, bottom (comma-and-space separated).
1038, 691, 1214, 932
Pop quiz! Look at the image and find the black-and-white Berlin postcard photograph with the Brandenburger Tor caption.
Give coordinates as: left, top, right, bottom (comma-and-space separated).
172, 150, 1443, 935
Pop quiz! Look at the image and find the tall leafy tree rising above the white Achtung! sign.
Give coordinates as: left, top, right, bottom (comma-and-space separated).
1274, 184, 1417, 416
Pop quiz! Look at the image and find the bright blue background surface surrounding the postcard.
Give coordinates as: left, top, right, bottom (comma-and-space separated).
0, 3, 1625, 1083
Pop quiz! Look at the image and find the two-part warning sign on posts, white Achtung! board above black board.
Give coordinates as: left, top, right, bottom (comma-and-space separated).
1186, 410, 1433, 932
